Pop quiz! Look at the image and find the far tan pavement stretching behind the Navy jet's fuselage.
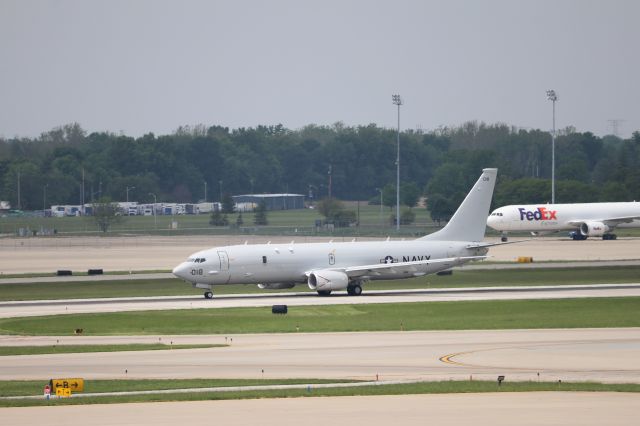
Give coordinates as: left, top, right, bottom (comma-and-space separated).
0, 236, 640, 275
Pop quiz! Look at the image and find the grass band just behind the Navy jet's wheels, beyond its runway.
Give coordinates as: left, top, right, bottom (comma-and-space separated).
0, 266, 640, 301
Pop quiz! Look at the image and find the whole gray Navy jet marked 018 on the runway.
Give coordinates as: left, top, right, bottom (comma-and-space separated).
173, 169, 500, 299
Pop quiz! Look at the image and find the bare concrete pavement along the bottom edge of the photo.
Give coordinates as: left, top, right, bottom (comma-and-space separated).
1, 392, 640, 426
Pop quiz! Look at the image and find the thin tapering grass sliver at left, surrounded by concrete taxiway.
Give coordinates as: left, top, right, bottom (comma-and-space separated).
0, 343, 227, 356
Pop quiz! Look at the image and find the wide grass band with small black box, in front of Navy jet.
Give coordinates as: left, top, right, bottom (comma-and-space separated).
0, 297, 640, 336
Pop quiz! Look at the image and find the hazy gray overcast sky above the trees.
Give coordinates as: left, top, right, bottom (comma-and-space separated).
0, 0, 640, 137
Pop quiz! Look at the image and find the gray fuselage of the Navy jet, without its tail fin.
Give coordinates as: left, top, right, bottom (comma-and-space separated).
173, 240, 487, 285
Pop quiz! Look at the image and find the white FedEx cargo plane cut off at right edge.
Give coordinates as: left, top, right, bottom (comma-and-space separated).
487, 202, 640, 241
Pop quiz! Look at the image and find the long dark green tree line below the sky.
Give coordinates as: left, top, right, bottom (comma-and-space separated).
0, 122, 640, 220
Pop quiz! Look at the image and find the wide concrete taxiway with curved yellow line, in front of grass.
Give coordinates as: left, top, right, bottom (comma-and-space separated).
0, 328, 640, 383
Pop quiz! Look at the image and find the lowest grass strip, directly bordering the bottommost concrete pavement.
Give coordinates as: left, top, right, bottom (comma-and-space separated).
0, 381, 640, 407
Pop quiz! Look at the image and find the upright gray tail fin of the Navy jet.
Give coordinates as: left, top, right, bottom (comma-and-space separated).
419, 169, 498, 241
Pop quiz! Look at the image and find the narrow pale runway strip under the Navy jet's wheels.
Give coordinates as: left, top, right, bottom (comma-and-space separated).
0, 283, 640, 318
